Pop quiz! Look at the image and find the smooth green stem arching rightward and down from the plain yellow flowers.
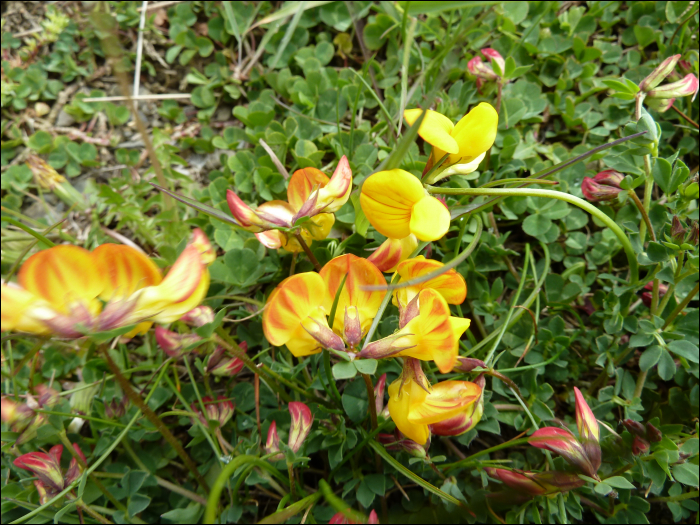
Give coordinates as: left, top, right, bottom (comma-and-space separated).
427, 186, 639, 283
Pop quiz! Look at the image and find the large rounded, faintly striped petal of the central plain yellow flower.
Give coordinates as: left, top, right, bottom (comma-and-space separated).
360, 169, 426, 239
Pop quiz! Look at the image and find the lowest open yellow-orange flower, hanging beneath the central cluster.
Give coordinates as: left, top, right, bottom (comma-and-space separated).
389, 359, 482, 445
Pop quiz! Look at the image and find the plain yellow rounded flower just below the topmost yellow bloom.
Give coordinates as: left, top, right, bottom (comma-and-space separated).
360, 169, 450, 241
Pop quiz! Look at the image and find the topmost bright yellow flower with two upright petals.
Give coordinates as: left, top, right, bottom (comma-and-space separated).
403, 102, 498, 183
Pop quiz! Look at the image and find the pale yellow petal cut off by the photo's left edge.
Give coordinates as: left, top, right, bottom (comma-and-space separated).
0, 283, 52, 334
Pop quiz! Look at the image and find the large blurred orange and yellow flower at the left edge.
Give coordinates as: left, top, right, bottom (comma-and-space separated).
2, 229, 216, 338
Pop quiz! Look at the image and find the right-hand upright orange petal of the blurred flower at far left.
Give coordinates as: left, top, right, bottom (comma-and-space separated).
92, 244, 163, 301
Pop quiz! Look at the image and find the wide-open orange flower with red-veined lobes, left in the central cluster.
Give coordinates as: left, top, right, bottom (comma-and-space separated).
263, 254, 386, 357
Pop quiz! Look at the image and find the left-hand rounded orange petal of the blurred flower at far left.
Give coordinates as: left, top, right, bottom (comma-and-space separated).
17, 244, 104, 314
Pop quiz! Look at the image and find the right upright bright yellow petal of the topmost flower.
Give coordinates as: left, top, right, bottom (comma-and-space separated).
443, 102, 498, 164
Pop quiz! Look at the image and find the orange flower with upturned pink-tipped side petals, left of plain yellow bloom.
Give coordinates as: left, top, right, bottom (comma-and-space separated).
226, 156, 352, 252
